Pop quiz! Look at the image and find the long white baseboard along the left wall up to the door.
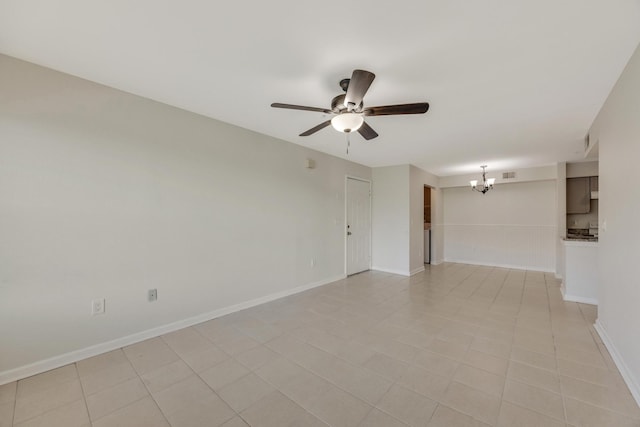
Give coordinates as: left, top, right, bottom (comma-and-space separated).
0, 275, 346, 385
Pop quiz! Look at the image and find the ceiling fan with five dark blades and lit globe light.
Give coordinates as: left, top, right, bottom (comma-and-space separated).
271, 70, 429, 140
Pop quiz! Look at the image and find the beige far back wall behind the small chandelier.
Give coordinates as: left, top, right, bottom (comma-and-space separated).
443, 180, 558, 272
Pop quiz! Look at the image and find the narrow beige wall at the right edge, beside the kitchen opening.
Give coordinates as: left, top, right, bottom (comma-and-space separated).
590, 42, 640, 404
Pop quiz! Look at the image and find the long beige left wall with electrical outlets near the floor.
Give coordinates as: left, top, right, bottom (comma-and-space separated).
0, 56, 371, 383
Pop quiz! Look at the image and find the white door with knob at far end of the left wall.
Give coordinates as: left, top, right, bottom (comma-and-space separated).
346, 178, 371, 275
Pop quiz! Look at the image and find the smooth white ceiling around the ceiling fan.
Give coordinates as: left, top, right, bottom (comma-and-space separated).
0, 0, 640, 176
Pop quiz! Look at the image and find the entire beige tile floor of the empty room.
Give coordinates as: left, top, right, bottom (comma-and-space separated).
0, 264, 640, 427
